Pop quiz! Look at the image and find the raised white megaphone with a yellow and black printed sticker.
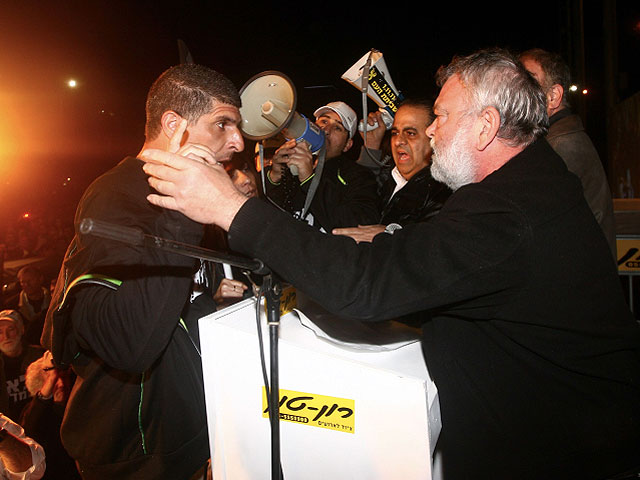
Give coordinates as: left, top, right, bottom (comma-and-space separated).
341, 49, 403, 131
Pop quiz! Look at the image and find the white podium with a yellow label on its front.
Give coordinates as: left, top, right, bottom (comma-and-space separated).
199, 299, 441, 480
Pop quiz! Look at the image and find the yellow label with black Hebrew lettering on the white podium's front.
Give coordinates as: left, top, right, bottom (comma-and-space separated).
262, 387, 356, 433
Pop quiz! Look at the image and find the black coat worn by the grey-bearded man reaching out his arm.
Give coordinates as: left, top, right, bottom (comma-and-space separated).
229, 140, 640, 480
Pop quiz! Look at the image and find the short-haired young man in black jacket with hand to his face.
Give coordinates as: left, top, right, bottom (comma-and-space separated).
42, 64, 244, 480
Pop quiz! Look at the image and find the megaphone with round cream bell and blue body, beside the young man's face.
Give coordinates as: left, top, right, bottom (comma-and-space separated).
240, 71, 325, 175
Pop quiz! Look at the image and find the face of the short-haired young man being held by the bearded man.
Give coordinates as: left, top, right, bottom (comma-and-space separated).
186, 102, 244, 162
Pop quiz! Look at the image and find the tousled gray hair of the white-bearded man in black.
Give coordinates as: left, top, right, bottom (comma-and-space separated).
436, 48, 549, 147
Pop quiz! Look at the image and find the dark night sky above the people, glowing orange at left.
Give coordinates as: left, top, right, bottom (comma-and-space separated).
0, 0, 640, 225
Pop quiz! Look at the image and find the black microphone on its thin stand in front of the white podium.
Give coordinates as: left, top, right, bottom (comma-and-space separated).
80, 218, 283, 480
